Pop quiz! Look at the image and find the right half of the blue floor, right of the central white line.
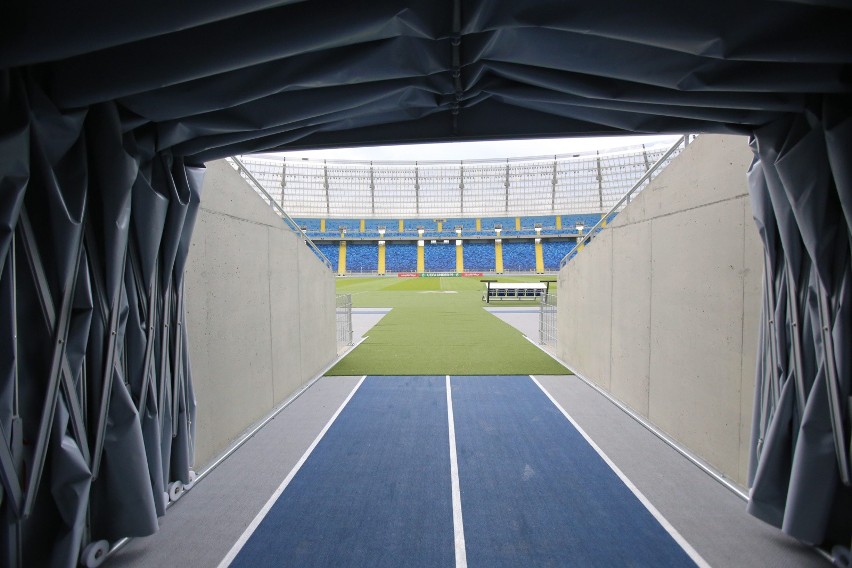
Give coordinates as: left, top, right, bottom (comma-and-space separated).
452, 377, 694, 568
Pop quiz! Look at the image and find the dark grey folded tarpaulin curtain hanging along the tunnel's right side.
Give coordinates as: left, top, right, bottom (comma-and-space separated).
748, 97, 852, 546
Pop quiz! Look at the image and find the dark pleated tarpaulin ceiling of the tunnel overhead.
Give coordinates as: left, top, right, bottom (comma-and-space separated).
0, 0, 852, 161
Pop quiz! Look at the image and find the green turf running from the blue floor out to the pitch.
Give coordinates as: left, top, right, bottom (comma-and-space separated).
327, 277, 569, 375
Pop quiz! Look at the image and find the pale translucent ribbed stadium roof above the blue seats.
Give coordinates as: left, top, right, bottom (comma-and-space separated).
239, 141, 667, 219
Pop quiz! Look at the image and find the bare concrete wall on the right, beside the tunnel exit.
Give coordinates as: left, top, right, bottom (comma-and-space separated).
557, 135, 763, 486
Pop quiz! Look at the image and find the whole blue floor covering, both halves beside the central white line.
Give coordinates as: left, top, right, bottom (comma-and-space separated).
223, 376, 695, 568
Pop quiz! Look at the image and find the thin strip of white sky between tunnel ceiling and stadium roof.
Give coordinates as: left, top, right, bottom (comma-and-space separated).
258, 135, 679, 161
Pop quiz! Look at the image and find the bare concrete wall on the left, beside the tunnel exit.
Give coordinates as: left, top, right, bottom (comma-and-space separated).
186, 161, 337, 469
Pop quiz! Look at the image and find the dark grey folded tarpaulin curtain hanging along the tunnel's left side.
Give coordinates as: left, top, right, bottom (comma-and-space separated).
0, 72, 204, 567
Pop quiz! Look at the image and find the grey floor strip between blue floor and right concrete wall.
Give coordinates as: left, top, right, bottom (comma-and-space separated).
536, 376, 828, 568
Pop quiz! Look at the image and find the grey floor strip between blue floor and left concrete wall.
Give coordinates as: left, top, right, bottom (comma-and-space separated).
105, 377, 361, 568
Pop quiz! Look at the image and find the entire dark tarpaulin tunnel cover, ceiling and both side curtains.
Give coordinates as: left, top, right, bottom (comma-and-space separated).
0, 0, 852, 566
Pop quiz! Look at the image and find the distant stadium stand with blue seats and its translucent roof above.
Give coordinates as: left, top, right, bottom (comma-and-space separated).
243, 141, 679, 273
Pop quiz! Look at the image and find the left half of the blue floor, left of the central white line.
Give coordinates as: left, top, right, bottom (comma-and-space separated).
232, 377, 454, 568
